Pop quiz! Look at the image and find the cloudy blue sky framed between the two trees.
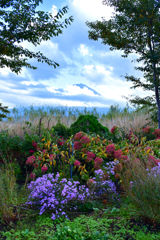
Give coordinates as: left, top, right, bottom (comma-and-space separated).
0, 0, 144, 108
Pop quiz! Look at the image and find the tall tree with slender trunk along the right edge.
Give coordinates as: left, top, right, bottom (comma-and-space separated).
87, 0, 160, 128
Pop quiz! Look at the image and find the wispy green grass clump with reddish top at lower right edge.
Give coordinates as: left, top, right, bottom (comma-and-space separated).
122, 160, 160, 223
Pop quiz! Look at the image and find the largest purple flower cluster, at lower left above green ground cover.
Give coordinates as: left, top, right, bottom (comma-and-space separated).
27, 173, 90, 220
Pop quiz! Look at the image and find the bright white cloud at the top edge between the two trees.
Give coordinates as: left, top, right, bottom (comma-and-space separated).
70, 0, 113, 21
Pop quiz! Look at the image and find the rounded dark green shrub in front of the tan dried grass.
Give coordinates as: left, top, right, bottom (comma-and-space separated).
70, 114, 109, 136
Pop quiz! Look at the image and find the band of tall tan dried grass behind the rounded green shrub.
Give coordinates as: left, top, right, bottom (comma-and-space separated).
0, 113, 153, 137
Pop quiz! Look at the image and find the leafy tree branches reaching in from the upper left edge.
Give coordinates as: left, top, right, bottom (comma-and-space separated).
0, 0, 73, 120
